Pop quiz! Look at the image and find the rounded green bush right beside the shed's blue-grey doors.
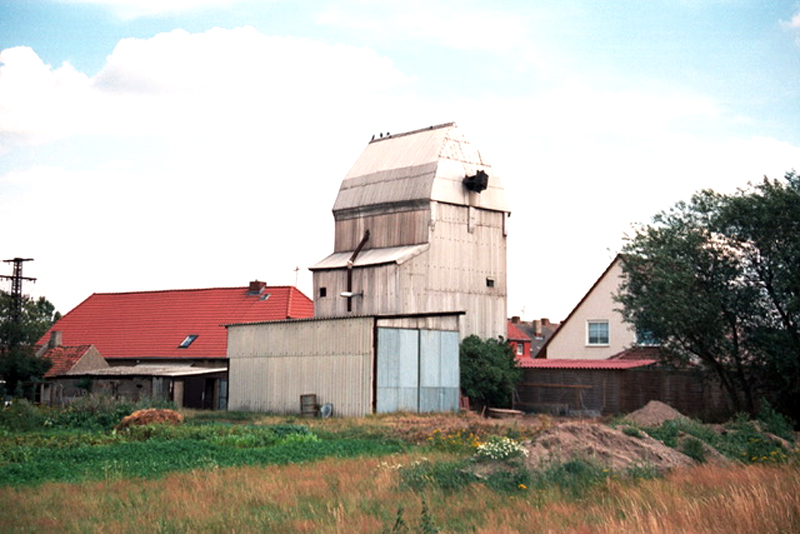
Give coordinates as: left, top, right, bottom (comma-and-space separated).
460, 335, 522, 407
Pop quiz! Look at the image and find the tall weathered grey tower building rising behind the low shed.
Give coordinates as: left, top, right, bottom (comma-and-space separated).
311, 123, 510, 338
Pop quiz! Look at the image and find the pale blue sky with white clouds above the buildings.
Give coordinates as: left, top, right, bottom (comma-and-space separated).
0, 0, 800, 321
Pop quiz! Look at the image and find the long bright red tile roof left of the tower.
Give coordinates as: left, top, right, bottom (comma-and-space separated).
39, 286, 314, 360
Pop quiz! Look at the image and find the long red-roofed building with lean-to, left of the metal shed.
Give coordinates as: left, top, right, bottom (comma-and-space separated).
38, 281, 313, 409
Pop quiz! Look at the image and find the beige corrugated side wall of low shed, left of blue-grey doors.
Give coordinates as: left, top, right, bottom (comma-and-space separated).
228, 317, 374, 416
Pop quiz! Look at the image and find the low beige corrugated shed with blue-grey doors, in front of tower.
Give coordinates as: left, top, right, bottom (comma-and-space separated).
228, 313, 460, 416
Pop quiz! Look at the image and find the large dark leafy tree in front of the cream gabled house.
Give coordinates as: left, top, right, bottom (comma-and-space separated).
617, 172, 800, 420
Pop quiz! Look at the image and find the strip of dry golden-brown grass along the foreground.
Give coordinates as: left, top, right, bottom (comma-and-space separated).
0, 454, 800, 534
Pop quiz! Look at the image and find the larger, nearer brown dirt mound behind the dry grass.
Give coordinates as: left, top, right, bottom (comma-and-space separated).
524, 422, 695, 471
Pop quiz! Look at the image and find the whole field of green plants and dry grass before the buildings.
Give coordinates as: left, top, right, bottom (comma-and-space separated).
0, 400, 800, 534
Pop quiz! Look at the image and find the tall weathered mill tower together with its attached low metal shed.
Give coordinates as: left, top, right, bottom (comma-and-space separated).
228, 123, 509, 415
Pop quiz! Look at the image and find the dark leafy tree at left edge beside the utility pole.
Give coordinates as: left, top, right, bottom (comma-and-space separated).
0, 291, 61, 396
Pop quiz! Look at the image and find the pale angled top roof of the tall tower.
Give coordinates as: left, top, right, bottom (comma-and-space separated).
333, 122, 510, 218
